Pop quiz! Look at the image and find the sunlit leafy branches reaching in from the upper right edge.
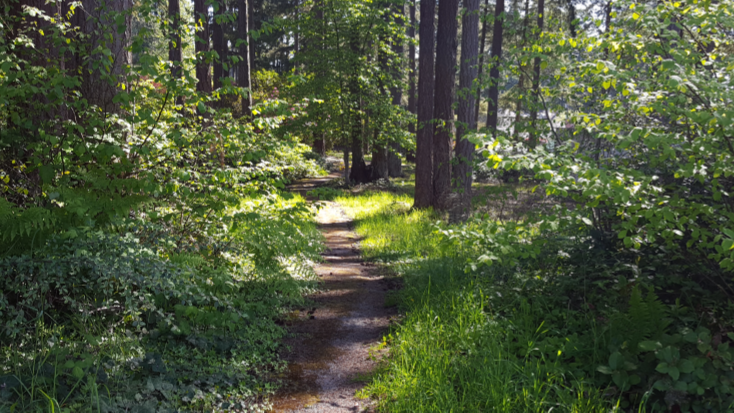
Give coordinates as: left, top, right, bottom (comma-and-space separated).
485, 1, 734, 274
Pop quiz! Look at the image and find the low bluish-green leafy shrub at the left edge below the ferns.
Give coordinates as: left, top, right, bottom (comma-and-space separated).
0, 232, 193, 339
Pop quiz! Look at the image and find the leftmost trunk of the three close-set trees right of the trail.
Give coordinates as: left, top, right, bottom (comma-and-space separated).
413, 0, 436, 208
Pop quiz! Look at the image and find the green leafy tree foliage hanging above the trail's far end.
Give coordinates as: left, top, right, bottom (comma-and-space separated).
288, 0, 414, 148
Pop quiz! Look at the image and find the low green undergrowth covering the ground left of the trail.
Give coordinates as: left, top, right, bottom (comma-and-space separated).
0, 195, 323, 412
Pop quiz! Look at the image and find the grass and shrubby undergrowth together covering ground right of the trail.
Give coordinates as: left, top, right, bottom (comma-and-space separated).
337, 192, 734, 412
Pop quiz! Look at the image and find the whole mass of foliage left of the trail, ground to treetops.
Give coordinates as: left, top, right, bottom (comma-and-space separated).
0, 0, 323, 412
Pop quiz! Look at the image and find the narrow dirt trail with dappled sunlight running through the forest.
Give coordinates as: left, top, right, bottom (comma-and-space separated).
272, 178, 394, 413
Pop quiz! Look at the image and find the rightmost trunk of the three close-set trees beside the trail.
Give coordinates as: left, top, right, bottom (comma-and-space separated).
452, 0, 484, 221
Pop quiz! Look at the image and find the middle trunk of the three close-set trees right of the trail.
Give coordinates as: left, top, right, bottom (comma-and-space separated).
433, 0, 459, 211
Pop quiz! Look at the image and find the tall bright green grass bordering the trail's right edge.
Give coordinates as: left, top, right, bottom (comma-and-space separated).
338, 192, 615, 412
